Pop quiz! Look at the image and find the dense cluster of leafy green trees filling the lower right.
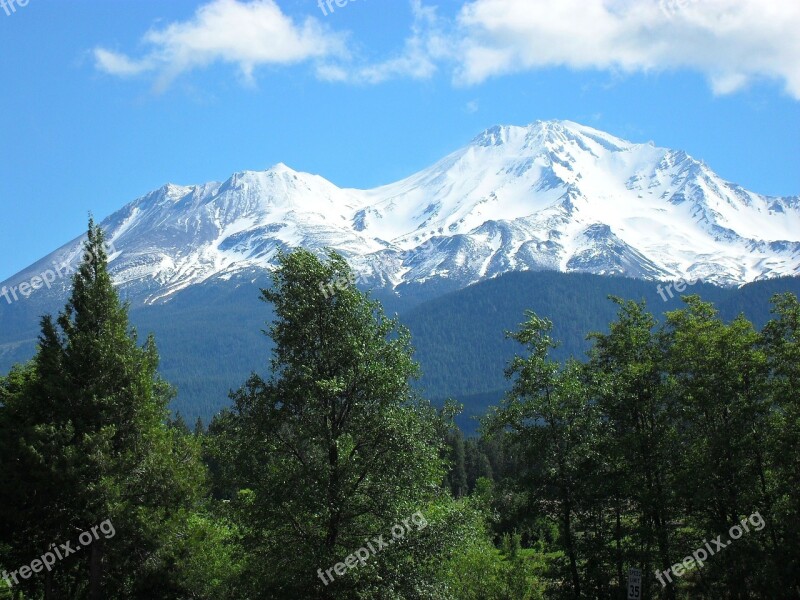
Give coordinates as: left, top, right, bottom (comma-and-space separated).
485, 294, 800, 599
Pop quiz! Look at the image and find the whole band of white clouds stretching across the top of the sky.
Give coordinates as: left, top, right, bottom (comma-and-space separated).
94, 0, 800, 99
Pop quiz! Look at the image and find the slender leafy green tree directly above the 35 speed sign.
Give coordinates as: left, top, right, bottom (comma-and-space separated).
588, 298, 679, 598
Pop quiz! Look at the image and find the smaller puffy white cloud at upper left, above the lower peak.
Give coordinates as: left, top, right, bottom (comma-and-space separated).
94, 0, 346, 86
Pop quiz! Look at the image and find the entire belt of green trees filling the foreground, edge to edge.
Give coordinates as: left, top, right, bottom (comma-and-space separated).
0, 223, 800, 600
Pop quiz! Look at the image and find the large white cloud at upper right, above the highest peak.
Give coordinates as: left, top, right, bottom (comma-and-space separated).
456, 0, 800, 99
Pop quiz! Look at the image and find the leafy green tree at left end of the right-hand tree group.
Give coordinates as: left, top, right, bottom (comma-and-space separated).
487, 312, 602, 599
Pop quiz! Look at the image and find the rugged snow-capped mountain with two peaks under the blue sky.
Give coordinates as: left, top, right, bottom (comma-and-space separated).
5, 121, 800, 303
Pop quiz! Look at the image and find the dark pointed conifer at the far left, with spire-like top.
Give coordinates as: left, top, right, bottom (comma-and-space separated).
0, 220, 209, 600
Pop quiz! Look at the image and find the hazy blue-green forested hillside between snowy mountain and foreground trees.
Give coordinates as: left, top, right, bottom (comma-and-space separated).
136, 272, 800, 422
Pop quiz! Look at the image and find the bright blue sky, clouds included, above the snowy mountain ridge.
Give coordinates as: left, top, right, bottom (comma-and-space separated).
0, 0, 800, 280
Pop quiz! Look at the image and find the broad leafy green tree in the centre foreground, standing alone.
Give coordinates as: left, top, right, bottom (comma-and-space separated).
228, 250, 456, 598
